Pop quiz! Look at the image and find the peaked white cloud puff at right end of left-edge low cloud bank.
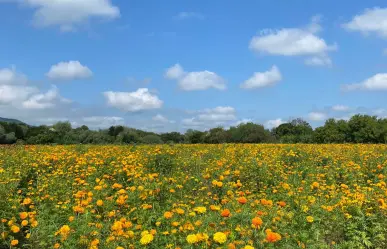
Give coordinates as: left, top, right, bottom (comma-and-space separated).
22, 86, 71, 109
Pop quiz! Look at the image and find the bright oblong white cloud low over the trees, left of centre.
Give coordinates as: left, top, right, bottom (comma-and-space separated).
103, 88, 163, 112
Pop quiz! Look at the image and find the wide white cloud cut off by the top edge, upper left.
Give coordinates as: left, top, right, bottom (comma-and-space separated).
19, 0, 120, 32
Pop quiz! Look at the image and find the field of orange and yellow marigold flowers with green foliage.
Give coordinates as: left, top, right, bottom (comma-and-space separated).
0, 144, 387, 249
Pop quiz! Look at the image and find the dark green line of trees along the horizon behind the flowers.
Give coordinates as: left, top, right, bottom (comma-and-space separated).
0, 114, 387, 144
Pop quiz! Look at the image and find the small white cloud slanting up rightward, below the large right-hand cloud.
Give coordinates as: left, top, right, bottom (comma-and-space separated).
241, 66, 282, 89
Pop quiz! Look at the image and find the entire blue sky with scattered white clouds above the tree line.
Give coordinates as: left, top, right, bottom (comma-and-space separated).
0, 0, 387, 132
